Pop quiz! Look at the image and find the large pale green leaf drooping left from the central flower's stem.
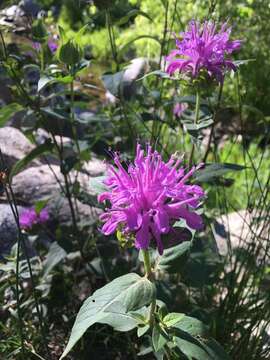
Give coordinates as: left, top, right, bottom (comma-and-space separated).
61, 273, 155, 359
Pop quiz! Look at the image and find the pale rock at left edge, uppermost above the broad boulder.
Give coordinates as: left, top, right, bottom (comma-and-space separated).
0, 126, 41, 169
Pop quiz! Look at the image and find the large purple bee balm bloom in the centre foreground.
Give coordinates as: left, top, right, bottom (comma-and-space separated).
98, 144, 204, 254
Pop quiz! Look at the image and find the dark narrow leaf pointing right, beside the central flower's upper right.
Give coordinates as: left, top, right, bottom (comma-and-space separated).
194, 163, 245, 182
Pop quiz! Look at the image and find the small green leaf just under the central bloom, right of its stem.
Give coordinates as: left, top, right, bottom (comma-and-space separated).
158, 241, 191, 273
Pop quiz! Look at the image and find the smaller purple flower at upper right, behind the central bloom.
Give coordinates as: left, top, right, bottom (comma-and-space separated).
167, 21, 241, 83
